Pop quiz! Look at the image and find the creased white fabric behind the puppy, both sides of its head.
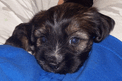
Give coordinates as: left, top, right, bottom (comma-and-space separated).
0, 0, 122, 44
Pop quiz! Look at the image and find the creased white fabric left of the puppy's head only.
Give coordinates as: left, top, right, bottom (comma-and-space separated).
0, 0, 58, 44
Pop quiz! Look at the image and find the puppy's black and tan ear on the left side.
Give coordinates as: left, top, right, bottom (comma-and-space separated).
5, 23, 31, 51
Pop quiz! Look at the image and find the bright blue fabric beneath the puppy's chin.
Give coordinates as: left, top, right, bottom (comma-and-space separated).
0, 36, 122, 81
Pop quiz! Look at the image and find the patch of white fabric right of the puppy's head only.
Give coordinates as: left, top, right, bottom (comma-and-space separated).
93, 0, 122, 41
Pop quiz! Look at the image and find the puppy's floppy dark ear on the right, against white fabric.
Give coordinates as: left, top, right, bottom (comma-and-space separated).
94, 13, 115, 42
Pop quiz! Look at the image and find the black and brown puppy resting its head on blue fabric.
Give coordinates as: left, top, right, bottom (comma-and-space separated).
5, 3, 114, 74
